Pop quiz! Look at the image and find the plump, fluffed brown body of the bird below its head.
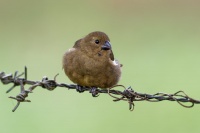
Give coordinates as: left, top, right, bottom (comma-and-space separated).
63, 49, 121, 88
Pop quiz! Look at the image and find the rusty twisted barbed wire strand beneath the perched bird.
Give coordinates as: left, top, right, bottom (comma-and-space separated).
0, 67, 200, 112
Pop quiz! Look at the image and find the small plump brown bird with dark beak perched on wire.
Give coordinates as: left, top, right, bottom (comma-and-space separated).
63, 31, 122, 96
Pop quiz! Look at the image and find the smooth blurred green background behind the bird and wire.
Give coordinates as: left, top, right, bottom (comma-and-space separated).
0, 0, 200, 133
